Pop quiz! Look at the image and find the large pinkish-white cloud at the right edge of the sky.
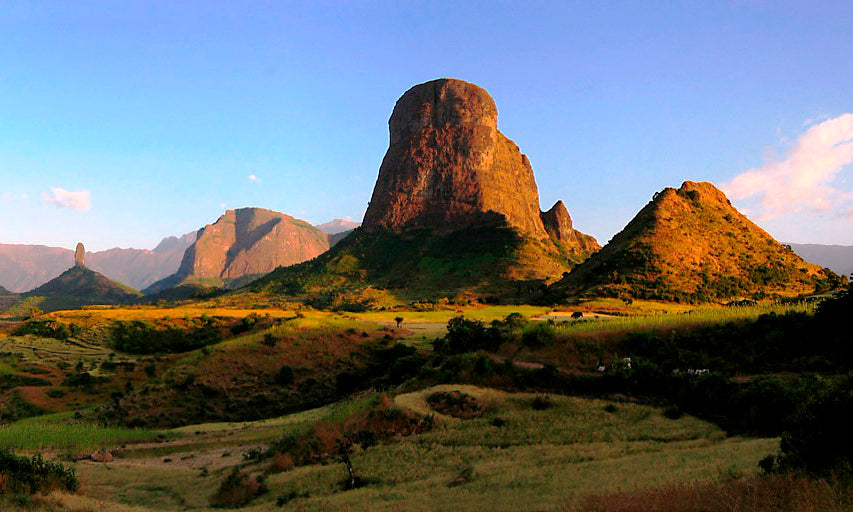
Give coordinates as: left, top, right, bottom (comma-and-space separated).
723, 114, 853, 219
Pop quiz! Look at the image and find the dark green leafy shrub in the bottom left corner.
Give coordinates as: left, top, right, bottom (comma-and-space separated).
0, 449, 80, 494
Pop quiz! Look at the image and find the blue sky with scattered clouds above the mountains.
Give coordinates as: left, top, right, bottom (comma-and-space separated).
0, 0, 853, 250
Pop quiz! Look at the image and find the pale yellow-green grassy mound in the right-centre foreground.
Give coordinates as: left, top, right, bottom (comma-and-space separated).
249, 386, 778, 510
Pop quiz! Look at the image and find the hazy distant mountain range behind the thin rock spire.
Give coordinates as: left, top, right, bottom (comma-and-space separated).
0, 233, 195, 292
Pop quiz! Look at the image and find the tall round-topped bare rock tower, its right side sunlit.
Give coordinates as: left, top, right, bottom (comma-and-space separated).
363, 78, 597, 256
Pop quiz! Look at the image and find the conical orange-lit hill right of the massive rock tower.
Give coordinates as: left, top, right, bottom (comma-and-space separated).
553, 181, 841, 301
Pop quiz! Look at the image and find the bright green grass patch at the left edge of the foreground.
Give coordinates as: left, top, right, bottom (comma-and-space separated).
0, 413, 164, 453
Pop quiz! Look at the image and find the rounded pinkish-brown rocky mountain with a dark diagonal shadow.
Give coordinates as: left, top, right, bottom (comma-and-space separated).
144, 208, 329, 294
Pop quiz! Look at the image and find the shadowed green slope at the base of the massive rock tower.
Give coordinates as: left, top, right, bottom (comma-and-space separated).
246, 224, 579, 310
